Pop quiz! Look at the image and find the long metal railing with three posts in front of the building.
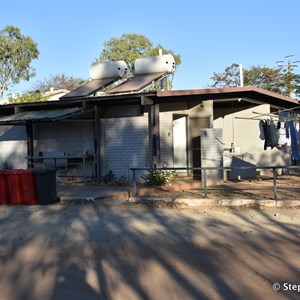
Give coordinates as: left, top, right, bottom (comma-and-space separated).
130, 166, 300, 200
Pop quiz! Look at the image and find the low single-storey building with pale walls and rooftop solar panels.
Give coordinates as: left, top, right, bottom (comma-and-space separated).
0, 56, 299, 180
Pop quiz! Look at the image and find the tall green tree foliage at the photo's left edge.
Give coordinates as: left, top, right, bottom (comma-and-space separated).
0, 25, 39, 99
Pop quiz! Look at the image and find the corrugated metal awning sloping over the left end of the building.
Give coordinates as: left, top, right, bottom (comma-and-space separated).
0, 107, 81, 124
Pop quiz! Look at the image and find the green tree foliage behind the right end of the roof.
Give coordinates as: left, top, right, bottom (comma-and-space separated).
211, 63, 300, 96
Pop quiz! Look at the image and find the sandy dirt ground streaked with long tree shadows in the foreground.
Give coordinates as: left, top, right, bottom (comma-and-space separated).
0, 204, 300, 300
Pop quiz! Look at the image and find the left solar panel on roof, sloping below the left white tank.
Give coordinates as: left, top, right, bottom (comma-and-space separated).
60, 77, 120, 99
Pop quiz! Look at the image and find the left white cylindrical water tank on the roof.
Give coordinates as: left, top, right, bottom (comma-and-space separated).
89, 60, 128, 79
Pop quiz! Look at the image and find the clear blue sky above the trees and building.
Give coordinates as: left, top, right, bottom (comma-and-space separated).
0, 0, 300, 93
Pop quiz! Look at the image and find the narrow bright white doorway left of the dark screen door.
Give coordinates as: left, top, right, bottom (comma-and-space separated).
173, 114, 188, 176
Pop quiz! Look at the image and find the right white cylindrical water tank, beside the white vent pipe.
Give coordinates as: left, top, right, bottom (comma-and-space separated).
134, 54, 175, 74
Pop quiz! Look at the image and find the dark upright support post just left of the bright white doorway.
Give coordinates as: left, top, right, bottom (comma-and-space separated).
150, 104, 160, 168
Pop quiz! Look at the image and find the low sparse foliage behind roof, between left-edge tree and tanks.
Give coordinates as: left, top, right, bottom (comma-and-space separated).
32, 74, 87, 92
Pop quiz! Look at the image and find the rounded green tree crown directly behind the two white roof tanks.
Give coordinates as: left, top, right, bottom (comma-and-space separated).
94, 33, 181, 73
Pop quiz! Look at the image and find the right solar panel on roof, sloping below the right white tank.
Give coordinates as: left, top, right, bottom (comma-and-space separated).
107, 72, 165, 94
